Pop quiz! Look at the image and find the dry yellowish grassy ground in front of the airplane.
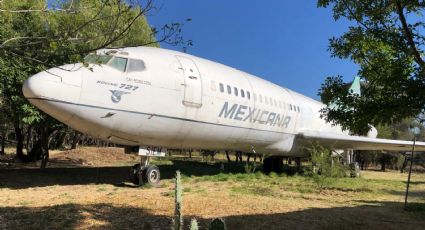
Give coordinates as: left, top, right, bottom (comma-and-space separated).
0, 148, 425, 229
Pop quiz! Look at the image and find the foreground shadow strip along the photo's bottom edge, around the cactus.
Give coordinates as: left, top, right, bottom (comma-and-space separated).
0, 202, 425, 230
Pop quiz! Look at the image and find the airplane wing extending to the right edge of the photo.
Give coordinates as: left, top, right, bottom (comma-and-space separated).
297, 131, 425, 151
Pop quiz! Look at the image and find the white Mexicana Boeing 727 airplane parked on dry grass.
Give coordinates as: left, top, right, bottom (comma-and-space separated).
23, 47, 425, 185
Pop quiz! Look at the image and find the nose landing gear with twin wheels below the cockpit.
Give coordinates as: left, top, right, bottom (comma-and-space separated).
130, 156, 161, 186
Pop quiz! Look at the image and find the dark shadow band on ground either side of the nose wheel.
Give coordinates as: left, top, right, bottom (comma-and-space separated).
0, 160, 244, 189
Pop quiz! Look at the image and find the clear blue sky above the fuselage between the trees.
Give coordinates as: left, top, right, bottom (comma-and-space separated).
148, 0, 358, 99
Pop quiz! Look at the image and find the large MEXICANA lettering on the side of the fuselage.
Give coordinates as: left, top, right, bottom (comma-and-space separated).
218, 101, 291, 128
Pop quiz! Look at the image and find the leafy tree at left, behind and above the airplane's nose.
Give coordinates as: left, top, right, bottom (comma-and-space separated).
0, 0, 191, 163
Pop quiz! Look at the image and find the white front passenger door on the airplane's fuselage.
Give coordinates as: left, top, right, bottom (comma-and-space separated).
177, 56, 202, 108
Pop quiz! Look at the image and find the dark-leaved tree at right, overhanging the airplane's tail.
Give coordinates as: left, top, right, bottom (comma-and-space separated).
318, 0, 425, 134
